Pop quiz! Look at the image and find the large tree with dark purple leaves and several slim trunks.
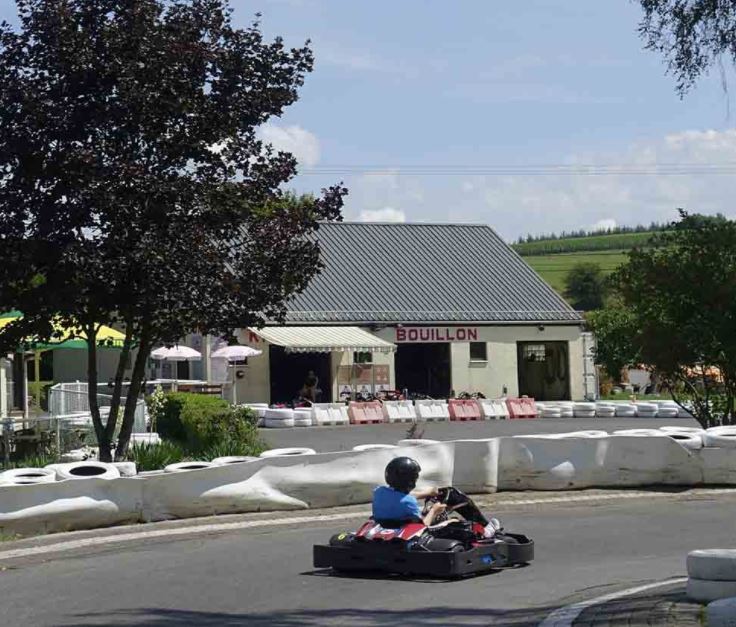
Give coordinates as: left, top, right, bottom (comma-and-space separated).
0, 0, 345, 460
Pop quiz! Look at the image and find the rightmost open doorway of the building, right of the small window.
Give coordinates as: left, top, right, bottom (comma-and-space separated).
516, 342, 570, 401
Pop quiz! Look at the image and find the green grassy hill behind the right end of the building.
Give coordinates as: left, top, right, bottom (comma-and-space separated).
513, 228, 662, 294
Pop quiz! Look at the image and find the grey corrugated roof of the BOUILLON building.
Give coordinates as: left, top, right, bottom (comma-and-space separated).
286, 222, 581, 323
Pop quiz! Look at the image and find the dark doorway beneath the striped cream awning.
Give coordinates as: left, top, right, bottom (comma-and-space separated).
268, 345, 332, 403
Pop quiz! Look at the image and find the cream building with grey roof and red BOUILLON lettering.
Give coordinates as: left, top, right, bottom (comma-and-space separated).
233, 222, 596, 403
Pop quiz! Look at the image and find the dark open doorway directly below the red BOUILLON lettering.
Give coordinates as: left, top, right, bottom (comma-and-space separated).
394, 342, 451, 398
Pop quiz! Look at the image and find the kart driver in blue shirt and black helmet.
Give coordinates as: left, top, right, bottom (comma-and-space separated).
373, 457, 447, 527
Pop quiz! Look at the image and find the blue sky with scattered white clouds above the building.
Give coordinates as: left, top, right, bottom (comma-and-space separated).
0, 0, 736, 240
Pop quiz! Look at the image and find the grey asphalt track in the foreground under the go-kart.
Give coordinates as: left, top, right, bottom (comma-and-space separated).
0, 491, 736, 627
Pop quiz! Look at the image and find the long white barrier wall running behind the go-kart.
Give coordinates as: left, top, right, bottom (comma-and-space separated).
10, 430, 736, 536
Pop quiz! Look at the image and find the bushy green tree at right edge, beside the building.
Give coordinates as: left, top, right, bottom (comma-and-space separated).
591, 211, 736, 427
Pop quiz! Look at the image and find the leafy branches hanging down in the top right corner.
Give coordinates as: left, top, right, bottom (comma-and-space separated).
639, 0, 736, 96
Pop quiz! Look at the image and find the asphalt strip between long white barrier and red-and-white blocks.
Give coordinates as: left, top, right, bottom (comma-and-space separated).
260, 418, 698, 453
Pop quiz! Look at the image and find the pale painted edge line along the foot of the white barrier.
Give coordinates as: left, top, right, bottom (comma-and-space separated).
0, 488, 736, 561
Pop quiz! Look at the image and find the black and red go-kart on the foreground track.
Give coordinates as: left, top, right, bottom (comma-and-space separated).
313, 488, 534, 578
